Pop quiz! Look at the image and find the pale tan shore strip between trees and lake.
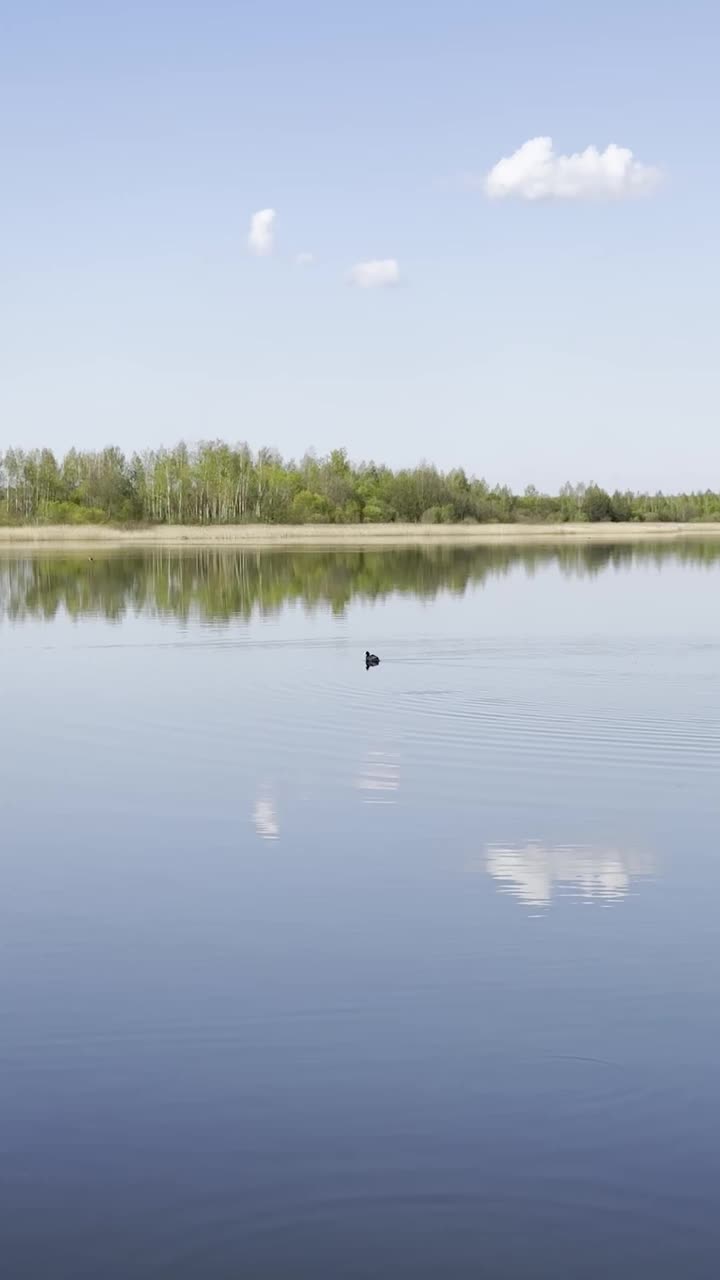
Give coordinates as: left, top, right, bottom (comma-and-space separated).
0, 522, 720, 549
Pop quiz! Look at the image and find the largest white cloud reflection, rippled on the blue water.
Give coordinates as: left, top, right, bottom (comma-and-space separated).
486, 841, 655, 906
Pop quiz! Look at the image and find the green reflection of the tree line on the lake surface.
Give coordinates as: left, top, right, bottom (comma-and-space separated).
0, 540, 720, 623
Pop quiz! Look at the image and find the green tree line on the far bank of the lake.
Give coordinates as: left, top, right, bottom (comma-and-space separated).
0, 440, 720, 525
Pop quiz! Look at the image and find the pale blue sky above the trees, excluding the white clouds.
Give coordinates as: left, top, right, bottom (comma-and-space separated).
0, 0, 720, 488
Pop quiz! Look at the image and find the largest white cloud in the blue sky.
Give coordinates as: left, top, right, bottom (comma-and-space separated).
484, 138, 661, 200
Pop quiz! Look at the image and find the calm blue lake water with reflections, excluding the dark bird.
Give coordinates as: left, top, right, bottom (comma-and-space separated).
0, 540, 720, 1280
